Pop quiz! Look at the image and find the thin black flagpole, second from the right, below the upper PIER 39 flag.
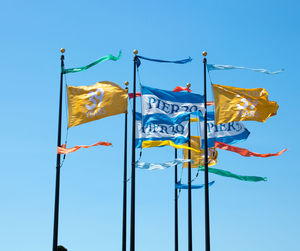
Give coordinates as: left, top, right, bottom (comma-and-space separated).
188, 116, 193, 251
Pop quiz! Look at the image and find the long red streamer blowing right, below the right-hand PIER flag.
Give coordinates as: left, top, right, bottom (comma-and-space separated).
215, 141, 287, 158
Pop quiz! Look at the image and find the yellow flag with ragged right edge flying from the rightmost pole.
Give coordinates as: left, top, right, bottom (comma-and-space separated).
212, 84, 279, 125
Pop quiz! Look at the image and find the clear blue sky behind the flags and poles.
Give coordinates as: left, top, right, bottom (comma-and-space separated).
0, 0, 300, 251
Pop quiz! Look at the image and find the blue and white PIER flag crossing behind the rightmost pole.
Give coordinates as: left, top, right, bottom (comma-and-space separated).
199, 112, 250, 149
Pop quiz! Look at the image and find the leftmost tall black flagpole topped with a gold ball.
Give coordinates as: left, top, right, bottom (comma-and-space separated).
53, 48, 65, 251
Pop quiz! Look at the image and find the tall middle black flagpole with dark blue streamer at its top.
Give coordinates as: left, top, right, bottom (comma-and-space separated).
130, 50, 138, 251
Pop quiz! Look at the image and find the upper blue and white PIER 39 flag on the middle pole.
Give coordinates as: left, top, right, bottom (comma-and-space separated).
142, 86, 204, 125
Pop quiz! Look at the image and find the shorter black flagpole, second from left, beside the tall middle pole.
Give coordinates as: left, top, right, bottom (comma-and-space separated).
122, 81, 128, 251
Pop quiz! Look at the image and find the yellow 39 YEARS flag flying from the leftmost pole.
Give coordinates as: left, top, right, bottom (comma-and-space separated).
67, 81, 127, 127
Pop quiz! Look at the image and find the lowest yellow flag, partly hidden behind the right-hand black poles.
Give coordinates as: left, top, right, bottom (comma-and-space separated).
183, 136, 218, 167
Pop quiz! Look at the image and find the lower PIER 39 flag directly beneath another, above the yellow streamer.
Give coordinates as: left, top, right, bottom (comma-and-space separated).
135, 112, 188, 148
